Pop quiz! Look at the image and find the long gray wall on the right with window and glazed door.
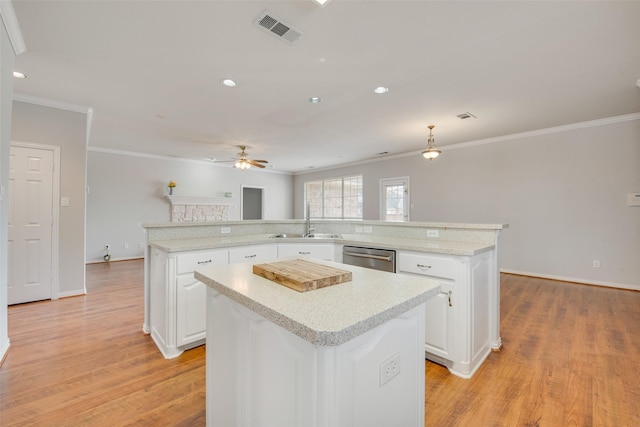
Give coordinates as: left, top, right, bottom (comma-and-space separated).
294, 115, 640, 289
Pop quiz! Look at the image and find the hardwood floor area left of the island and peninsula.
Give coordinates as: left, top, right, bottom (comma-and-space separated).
0, 260, 205, 426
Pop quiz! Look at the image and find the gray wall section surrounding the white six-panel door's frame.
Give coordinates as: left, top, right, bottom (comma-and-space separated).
11, 101, 87, 297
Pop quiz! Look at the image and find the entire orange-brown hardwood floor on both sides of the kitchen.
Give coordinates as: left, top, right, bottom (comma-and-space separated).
0, 261, 640, 427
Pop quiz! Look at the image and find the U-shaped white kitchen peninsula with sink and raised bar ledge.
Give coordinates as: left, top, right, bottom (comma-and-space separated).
143, 220, 508, 378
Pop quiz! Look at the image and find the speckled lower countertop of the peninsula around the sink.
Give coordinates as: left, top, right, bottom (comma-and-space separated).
150, 233, 495, 256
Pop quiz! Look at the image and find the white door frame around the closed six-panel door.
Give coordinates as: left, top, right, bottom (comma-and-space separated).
10, 141, 60, 301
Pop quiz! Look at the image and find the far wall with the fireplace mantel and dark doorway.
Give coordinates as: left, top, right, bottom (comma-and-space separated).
86, 149, 293, 262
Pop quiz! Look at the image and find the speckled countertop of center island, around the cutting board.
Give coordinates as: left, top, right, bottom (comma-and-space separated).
195, 259, 440, 346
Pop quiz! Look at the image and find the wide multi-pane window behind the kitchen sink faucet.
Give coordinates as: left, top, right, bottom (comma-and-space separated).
304, 175, 362, 219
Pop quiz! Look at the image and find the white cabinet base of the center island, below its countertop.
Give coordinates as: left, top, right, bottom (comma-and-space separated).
206, 288, 425, 427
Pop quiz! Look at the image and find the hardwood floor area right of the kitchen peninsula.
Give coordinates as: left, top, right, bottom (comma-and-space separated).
425, 274, 640, 426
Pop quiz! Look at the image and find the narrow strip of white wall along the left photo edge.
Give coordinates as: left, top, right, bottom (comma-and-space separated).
0, 12, 15, 364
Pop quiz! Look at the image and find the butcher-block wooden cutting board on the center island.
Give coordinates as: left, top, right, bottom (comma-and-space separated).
253, 259, 351, 292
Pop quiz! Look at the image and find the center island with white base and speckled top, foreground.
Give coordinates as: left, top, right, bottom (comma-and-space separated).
195, 259, 440, 427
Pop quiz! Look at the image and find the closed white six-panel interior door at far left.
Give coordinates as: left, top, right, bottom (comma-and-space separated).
8, 145, 54, 305
